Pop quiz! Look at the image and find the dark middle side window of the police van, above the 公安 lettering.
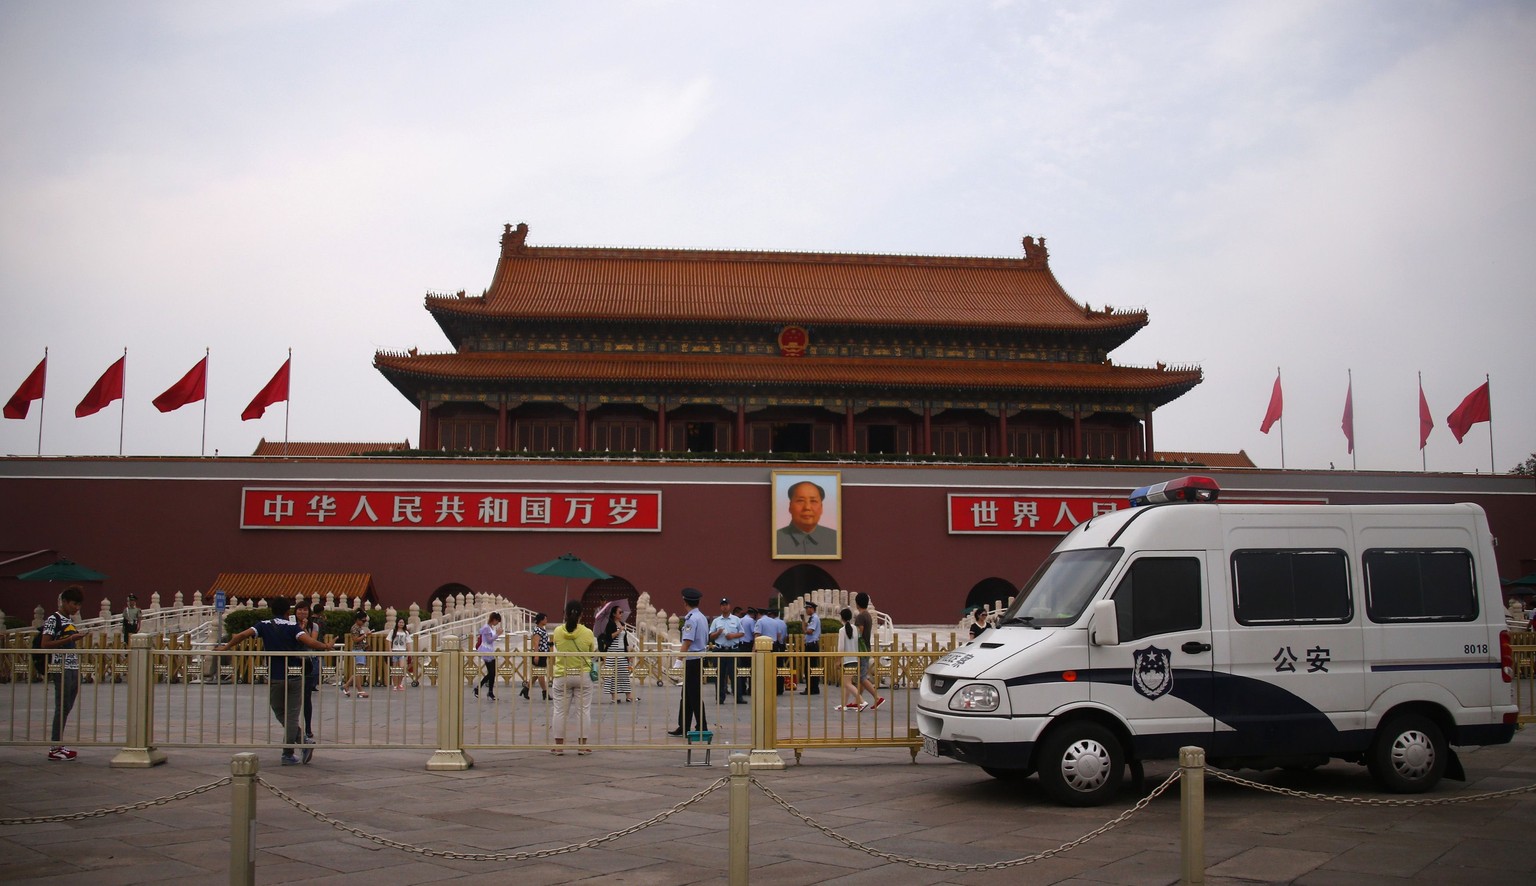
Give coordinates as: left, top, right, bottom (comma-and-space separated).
1232, 548, 1355, 625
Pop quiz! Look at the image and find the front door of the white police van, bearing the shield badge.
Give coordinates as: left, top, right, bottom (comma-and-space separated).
1089, 551, 1213, 757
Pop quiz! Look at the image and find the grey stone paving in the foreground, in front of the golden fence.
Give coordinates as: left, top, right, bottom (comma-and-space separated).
0, 718, 1536, 886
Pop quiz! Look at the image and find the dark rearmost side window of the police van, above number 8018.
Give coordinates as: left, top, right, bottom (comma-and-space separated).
1364, 548, 1478, 622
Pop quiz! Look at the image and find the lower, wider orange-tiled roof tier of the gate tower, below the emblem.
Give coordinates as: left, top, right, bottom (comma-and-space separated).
373, 352, 1201, 396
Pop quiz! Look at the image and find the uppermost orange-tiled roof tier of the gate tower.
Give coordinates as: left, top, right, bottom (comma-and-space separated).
427, 234, 1147, 332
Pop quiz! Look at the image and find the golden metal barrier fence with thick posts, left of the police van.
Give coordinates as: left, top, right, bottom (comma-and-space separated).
0, 636, 942, 768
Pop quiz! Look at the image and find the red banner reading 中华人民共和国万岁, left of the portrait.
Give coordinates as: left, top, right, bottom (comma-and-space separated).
240, 487, 662, 533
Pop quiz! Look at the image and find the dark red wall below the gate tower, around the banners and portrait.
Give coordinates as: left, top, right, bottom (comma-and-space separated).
0, 459, 1536, 623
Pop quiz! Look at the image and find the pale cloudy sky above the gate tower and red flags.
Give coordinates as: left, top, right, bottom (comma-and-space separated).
0, 0, 1536, 473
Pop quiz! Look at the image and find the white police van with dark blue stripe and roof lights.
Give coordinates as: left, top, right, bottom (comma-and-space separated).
917, 478, 1516, 806
